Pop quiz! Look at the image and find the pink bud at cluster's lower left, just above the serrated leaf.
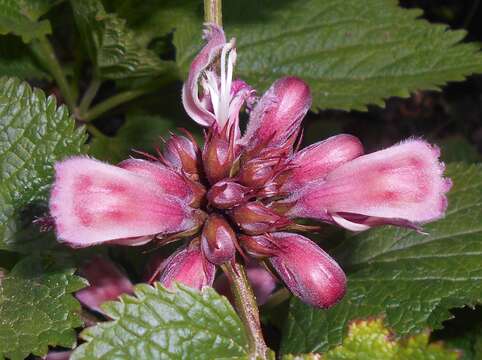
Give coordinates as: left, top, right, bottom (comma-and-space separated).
159, 241, 216, 290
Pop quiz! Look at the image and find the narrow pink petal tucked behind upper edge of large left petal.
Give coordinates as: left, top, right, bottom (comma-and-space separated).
118, 159, 192, 202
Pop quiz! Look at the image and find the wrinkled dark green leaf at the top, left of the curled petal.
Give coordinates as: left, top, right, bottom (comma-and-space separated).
70, 0, 173, 79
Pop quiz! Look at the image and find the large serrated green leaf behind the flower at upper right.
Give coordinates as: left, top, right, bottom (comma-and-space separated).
174, 0, 482, 110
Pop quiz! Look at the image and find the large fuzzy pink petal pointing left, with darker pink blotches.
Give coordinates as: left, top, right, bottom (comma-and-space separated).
50, 157, 194, 247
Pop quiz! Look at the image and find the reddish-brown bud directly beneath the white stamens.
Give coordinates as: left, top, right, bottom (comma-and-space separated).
202, 128, 235, 184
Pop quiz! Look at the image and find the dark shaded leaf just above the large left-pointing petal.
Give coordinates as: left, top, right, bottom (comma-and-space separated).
89, 114, 174, 163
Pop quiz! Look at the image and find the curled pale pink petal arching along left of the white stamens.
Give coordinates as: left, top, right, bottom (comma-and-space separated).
182, 24, 226, 126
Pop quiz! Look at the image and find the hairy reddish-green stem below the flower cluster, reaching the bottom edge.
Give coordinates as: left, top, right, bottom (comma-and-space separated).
222, 263, 269, 359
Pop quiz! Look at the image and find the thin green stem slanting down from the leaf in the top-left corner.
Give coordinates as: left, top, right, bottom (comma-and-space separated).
32, 36, 75, 113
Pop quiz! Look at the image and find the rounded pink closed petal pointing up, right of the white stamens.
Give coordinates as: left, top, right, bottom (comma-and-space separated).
242, 77, 311, 149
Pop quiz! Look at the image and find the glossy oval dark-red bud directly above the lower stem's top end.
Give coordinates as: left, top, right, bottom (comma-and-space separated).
201, 214, 236, 265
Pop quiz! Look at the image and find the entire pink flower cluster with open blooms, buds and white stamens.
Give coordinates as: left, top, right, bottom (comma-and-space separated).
50, 24, 451, 307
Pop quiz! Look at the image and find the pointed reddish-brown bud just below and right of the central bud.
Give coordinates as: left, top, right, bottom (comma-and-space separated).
231, 202, 290, 235
